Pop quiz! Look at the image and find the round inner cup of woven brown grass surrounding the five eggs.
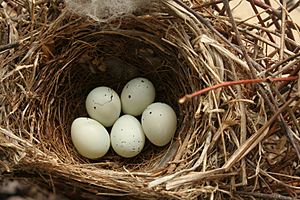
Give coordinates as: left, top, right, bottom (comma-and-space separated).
35, 16, 199, 166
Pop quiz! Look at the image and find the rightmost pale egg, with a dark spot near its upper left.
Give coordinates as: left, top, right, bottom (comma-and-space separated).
141, 102, 177, 146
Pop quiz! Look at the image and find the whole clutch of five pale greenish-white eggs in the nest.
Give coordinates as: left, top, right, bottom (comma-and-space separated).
71, 78, 177, 159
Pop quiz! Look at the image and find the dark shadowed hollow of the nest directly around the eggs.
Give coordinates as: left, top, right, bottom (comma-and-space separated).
39, 32, 197, 169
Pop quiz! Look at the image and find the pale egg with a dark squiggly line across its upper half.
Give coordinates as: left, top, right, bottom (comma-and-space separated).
85, 86, 121, 127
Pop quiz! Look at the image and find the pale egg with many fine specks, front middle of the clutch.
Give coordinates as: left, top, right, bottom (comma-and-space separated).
110, 115, 145, 158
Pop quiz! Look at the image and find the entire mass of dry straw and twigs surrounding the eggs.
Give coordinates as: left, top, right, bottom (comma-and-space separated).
0, 0, 300, 199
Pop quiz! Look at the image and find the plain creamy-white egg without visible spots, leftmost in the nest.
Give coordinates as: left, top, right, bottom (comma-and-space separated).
71, 117, 110, 159
